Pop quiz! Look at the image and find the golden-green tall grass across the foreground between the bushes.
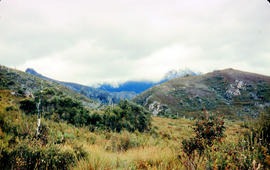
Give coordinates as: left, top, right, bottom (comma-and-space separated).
0, 91, 270, 170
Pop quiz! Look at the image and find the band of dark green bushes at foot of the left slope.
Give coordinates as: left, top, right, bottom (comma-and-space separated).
17, 88, 151, 132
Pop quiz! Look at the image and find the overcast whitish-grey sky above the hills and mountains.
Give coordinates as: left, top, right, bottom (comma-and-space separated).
0, 0, 270, 85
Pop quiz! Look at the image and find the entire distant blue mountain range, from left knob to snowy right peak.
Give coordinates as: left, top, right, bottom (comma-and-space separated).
25, 68, 198, 104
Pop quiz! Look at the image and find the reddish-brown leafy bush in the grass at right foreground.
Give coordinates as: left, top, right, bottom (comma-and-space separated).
179, 111, 225, 169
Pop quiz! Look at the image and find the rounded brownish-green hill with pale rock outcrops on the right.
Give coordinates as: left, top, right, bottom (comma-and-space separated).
133, 69, 270, 118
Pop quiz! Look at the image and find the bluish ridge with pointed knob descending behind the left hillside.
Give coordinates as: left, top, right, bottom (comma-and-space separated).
25, 68, 136, 104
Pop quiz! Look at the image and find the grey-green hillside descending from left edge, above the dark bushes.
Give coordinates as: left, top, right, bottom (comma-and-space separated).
0, 65, 101, 108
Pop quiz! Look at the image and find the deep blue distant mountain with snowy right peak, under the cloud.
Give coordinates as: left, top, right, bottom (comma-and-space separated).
99, 69, 200, 94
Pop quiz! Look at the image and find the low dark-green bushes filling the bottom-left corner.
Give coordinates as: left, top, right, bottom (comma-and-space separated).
0, 142, 87, 169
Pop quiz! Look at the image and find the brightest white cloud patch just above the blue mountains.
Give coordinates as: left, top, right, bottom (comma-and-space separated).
135, 44, 201, 81
